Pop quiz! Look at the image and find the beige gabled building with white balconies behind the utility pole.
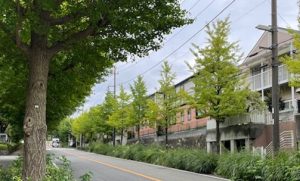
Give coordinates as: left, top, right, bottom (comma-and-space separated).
206, 28, 300, 154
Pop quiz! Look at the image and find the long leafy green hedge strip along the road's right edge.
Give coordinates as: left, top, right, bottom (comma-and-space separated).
86, 143, 300, 181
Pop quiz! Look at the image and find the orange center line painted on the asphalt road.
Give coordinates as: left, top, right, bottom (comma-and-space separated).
62, 151, 161, 181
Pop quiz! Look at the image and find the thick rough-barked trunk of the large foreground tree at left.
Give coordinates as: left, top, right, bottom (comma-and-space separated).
23, 51, 49, 181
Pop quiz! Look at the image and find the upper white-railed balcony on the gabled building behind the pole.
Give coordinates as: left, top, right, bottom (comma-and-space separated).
249, 65, 290, 91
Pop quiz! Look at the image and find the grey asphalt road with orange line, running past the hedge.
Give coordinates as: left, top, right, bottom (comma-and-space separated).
48, 148, 226, 181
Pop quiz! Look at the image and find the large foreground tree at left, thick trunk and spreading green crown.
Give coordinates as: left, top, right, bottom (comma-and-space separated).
0, 0, 189, 181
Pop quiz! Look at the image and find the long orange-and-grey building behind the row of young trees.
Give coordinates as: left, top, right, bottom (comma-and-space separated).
134, 76, 208, 148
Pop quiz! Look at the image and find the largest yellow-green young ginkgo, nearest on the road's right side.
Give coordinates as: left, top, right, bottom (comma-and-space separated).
189, 18, 264, 153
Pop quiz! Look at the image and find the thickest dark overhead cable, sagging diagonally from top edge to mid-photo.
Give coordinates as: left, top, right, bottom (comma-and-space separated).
118, 0, 236, 84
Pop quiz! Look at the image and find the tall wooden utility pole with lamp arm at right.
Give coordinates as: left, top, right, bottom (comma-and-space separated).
256, 0, 280, 153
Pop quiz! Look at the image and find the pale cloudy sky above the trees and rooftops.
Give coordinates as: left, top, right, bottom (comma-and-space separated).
74, 0, 299, 115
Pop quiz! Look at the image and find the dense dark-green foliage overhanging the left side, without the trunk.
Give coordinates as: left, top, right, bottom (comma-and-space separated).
0, 0, 191, 137
